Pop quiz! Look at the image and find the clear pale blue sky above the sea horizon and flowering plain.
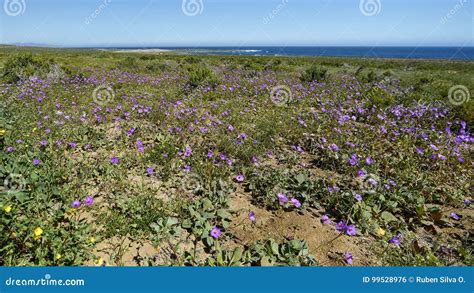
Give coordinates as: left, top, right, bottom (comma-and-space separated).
0, 0, 474, 46
